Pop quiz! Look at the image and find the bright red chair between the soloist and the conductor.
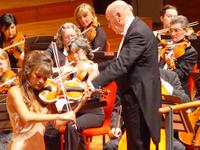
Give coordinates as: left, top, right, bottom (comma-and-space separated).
81, 81, 117, 150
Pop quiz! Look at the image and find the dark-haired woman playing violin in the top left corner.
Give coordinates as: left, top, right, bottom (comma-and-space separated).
0, 13, 25, 68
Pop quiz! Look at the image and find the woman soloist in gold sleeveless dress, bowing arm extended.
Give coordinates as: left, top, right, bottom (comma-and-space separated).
7, 51, 75, 150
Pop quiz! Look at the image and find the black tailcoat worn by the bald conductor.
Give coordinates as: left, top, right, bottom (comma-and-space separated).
92, 17, 161, 143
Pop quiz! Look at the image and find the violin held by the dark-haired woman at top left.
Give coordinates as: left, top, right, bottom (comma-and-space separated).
3, 33, 25, 67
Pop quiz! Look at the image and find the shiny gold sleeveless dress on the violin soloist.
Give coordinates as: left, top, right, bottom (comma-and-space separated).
7, 105, 45, 150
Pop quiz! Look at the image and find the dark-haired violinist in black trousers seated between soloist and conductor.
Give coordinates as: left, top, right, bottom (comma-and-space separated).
45, 37, 104, 150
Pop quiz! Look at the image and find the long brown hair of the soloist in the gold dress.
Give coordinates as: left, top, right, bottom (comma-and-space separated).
19, 50, 53, 112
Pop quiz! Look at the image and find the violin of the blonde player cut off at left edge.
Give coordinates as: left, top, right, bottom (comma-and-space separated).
0, 70, 17, 94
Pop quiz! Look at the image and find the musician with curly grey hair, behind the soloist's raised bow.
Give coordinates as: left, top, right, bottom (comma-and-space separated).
46, 23, 82, 75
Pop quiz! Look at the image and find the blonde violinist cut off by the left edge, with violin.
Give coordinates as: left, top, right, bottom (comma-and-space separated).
0, 50, 17, 94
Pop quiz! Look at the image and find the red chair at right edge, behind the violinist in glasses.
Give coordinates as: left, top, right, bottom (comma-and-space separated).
188, 64, 199, 100
